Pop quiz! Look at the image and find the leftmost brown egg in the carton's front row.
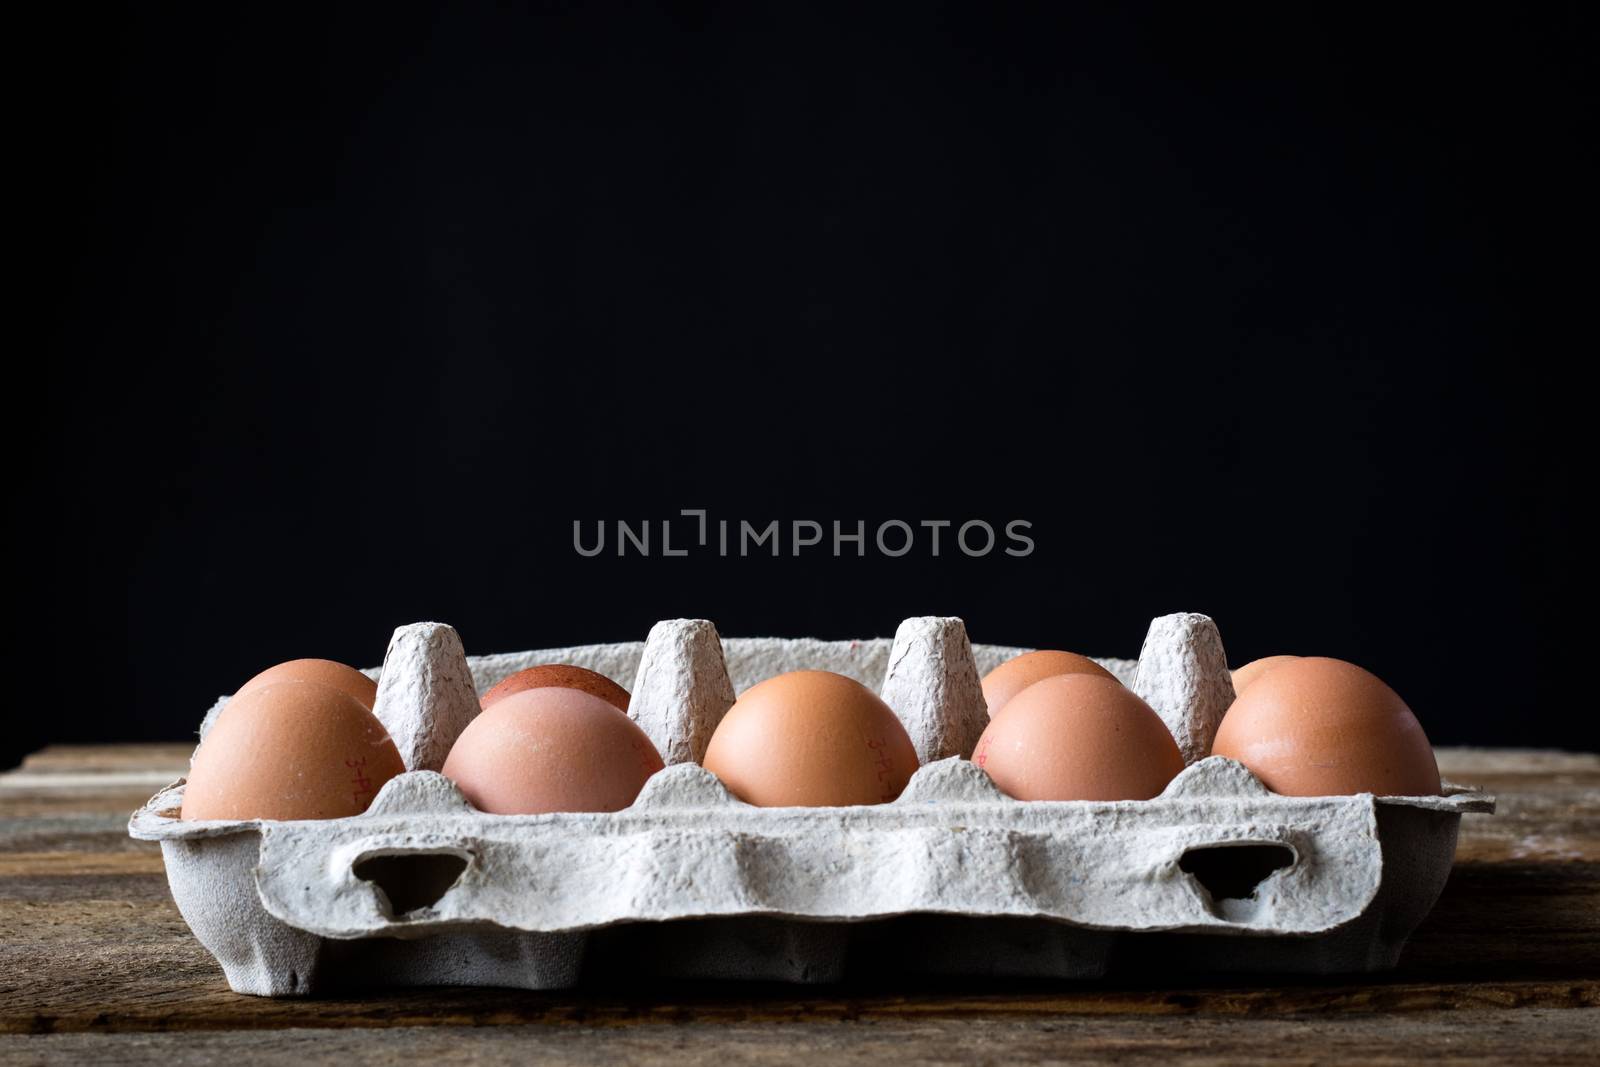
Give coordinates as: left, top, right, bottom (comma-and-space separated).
182, 681, 405, 819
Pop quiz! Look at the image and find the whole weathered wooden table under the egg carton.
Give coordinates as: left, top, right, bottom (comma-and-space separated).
0, 745, 1600, 1067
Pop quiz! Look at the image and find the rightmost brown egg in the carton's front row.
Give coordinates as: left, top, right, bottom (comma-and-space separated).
1211, 656, 1438, 797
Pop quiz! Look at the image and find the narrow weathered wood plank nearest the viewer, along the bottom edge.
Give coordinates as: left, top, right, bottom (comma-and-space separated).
9, 1009, 1600, 1067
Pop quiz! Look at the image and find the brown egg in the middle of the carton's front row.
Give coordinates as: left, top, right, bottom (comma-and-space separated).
702, 670, 917, 808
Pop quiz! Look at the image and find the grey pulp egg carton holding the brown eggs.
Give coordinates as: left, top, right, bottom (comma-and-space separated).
130, 613, 1494, 997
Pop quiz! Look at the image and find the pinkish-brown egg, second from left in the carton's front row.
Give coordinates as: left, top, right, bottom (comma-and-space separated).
443, 686, 664, 814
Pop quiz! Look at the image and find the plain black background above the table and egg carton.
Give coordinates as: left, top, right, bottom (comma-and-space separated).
18, 3, 1597, 763
